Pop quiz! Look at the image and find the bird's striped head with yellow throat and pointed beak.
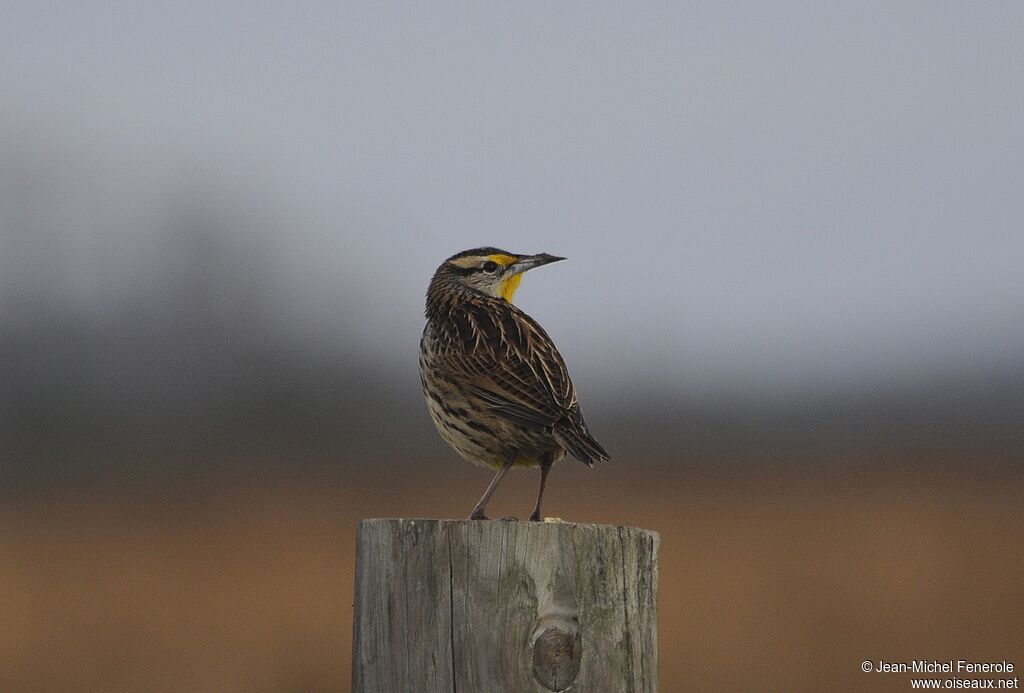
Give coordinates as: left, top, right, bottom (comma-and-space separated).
435, 248, 565, 303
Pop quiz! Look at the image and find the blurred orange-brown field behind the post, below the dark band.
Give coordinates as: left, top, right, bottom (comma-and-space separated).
0, 456, 1024, 692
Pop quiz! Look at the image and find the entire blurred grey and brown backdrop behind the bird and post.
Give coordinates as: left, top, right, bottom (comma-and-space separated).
0, 0, 1024, 691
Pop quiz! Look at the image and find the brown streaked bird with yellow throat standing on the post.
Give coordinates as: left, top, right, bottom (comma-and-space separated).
420, 247, 609, 521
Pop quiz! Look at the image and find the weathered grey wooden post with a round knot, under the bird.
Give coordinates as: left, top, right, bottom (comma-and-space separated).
352, 519, 658, 693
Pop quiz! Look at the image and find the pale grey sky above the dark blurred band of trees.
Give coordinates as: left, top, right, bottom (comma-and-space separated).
0, 1, 1024, 390
